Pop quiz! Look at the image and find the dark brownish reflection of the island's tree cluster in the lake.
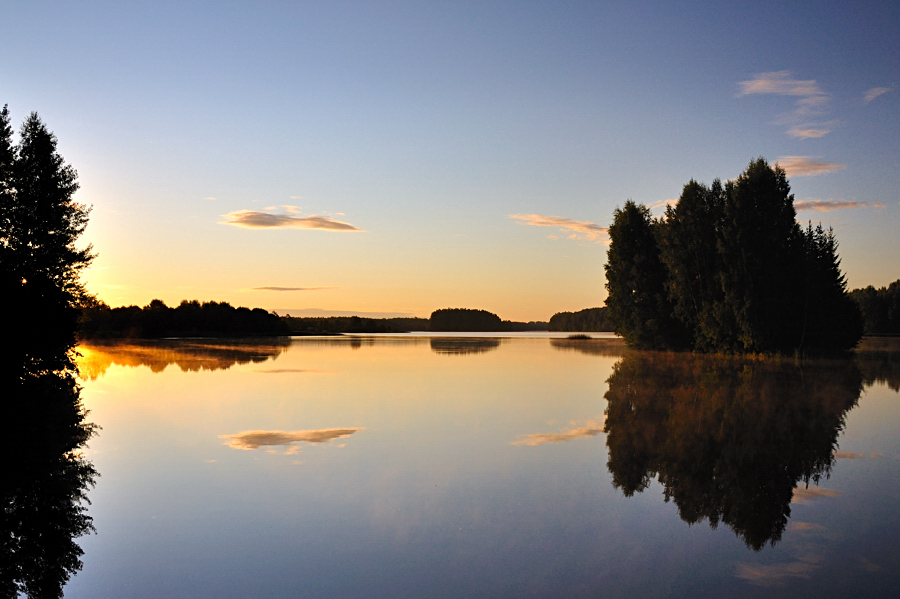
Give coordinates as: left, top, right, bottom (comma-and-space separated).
606, 352, 863, 551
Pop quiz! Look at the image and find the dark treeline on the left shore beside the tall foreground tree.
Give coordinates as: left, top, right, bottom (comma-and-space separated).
81, 299, 291, 339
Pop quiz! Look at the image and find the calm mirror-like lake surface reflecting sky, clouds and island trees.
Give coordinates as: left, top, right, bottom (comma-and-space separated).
59, 337, 900, 598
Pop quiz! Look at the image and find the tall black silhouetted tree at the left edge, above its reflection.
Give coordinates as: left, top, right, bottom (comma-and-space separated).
0, 107, 93, 369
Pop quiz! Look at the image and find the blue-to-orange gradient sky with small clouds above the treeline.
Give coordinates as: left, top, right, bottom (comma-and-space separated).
0, 0, 900, 320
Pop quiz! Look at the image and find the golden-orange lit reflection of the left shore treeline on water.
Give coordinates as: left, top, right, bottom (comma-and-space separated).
78, 338, 290, 380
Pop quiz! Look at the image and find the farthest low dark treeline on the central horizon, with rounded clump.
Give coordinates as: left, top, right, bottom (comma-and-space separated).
284, 308, 547, 335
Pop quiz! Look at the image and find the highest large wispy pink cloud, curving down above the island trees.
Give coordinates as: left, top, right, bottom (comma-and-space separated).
738, 71, 834, 139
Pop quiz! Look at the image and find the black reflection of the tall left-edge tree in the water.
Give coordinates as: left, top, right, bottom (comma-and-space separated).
0, 358, 98, 597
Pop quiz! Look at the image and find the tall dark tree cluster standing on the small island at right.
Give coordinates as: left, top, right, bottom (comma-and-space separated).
606, 158, 863, 354
